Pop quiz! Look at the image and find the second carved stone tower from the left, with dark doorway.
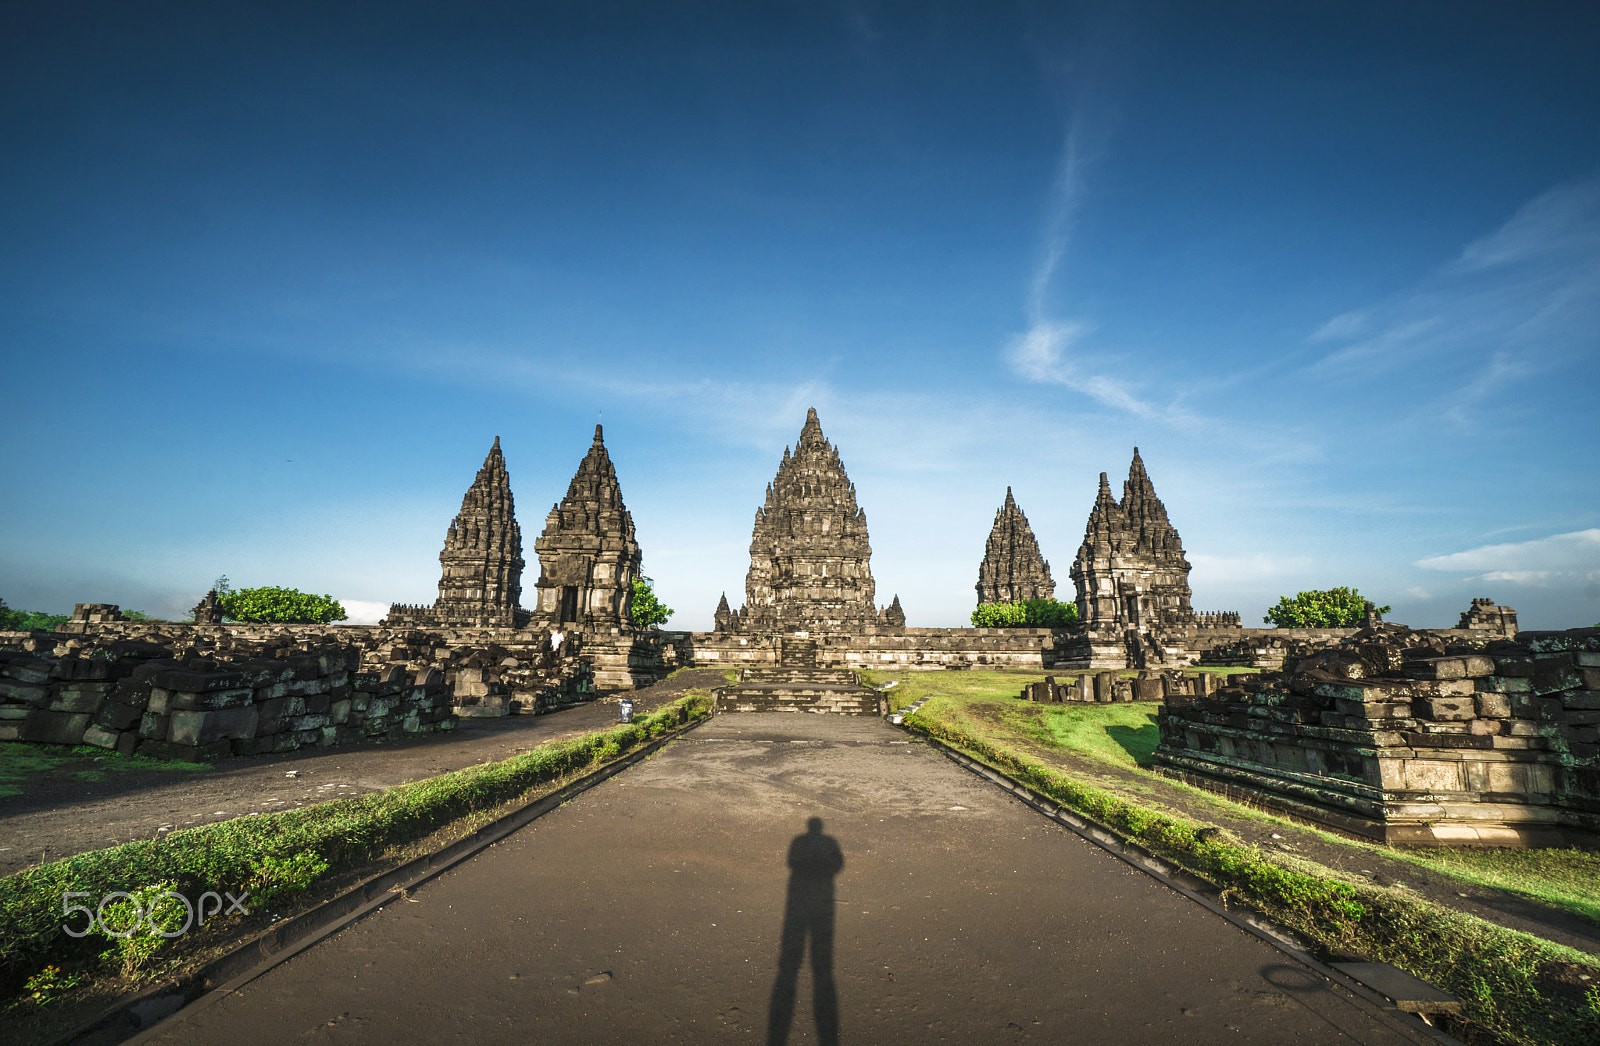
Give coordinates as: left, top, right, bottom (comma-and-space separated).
533, 425, 640, 632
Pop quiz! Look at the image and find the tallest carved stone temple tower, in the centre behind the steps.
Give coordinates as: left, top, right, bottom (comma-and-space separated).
736, 408, 878, 633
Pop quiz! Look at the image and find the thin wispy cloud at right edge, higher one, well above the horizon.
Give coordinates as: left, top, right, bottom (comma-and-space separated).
1310, 176, 1600, 409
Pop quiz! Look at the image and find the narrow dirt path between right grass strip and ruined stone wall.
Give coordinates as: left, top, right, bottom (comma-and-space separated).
970, 704, 1600, 953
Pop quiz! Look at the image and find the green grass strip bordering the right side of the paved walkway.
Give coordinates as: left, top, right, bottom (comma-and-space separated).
906, 709, 1600, 1046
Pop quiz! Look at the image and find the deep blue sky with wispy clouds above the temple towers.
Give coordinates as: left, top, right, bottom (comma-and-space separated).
0, 0, 1600, 629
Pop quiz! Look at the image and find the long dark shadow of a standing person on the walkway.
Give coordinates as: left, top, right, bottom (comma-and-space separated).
766, 817, 845, 1046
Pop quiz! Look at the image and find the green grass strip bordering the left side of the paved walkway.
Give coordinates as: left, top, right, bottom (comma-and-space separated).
0, 693, 710, 1001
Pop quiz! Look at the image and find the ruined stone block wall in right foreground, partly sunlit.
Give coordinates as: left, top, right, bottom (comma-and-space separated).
1155, 625, 1600, 846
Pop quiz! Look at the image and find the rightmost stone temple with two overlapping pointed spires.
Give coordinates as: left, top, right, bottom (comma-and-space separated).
1072, 448, 1195, 665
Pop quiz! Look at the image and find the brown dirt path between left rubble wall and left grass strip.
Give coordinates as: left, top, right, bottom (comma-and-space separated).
0, 669, 726, 875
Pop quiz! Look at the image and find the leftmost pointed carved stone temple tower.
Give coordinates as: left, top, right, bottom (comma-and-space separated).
432, 437, 525, 629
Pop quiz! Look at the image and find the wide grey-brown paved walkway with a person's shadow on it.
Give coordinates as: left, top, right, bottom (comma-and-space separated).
142, 713, 1430, 1046
